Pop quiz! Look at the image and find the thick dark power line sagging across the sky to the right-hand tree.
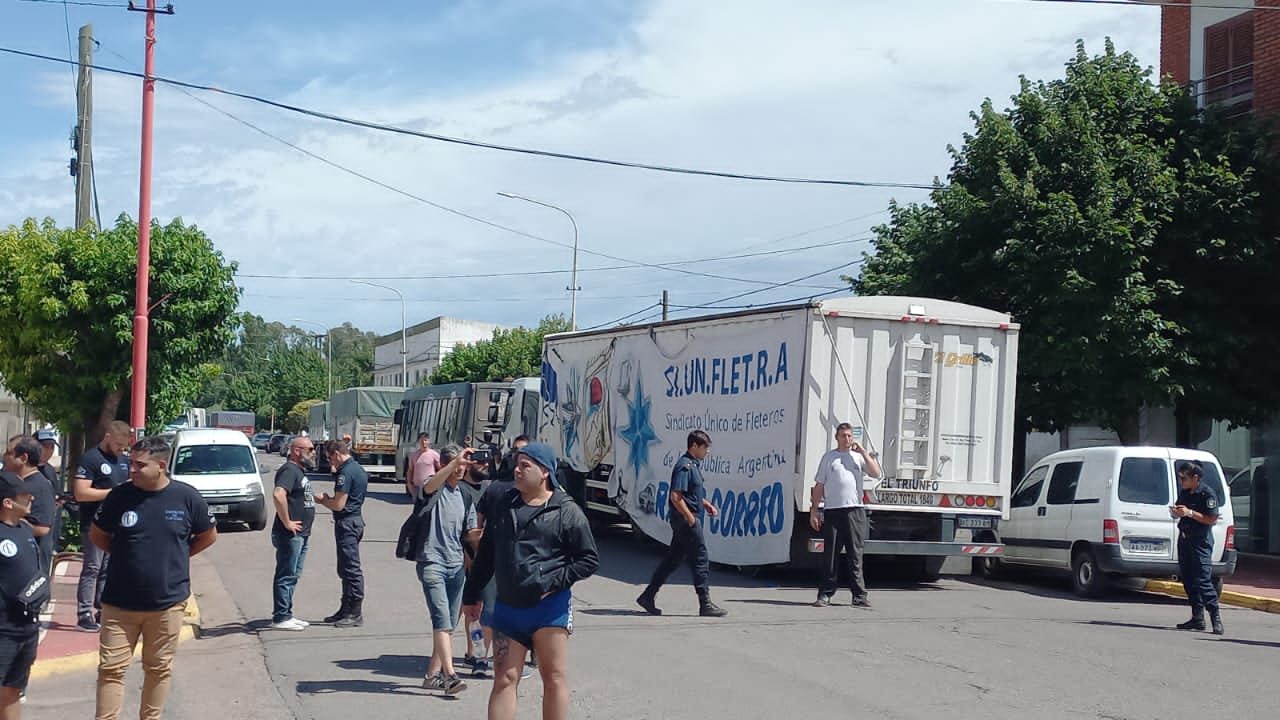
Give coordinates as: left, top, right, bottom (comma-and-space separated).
0, 47, 938, 190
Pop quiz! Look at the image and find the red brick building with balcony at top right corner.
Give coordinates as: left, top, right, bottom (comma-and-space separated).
1160, 0, 1280, 115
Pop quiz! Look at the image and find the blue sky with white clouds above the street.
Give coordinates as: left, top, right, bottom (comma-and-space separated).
0, 0, 1160, 333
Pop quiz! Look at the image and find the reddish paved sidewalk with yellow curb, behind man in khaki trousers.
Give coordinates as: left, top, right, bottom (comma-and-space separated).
31, 556, 200, 679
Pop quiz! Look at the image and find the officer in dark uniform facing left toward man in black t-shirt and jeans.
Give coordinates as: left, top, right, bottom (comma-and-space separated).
316, 439, 369, 628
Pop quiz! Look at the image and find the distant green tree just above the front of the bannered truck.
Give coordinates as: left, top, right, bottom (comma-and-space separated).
429, 315, 568, 384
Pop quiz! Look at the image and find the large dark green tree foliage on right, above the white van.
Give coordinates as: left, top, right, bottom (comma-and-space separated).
850, 42, 1280, 441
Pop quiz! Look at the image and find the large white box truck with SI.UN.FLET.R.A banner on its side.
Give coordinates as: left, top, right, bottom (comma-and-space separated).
539, 297, 1019, 579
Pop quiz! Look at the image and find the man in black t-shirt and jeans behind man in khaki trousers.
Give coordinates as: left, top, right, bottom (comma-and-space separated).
72, 420, 132, 633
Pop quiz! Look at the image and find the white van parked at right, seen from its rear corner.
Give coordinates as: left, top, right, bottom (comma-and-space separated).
978, 447, 1236, 597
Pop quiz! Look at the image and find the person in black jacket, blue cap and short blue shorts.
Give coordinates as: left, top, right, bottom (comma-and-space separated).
462, 442, 600, 720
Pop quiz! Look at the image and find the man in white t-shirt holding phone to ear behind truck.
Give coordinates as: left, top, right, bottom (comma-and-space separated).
809, 423, 881, 607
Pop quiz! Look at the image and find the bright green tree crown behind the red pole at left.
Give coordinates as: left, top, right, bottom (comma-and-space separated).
0, 215, 239, 442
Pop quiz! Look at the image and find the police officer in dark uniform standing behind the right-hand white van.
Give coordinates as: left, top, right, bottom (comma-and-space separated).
1169, 462, 1225, 635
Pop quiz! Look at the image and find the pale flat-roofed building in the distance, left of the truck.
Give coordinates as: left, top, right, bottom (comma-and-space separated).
374, 318, 506, 387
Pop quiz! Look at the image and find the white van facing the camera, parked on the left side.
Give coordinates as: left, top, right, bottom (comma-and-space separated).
169, 428, 266, 530
